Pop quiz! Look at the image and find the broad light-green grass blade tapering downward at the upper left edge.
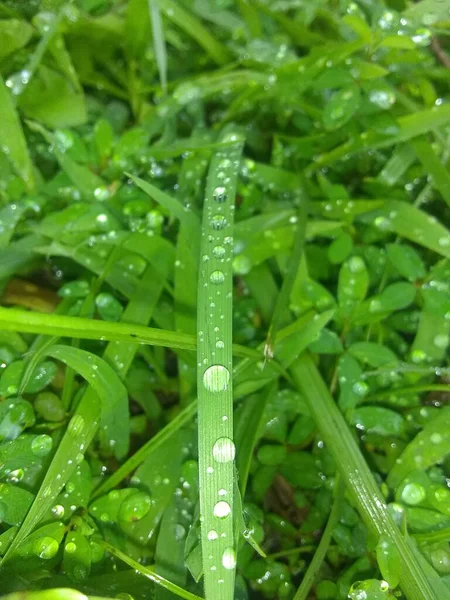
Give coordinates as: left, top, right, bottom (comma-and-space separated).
0, 76, 34, 191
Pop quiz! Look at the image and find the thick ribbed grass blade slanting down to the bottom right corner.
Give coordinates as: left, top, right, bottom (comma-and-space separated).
291, 354, 450, 600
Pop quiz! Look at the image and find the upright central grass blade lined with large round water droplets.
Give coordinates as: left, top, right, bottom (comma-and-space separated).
197, 127, 243, 600
